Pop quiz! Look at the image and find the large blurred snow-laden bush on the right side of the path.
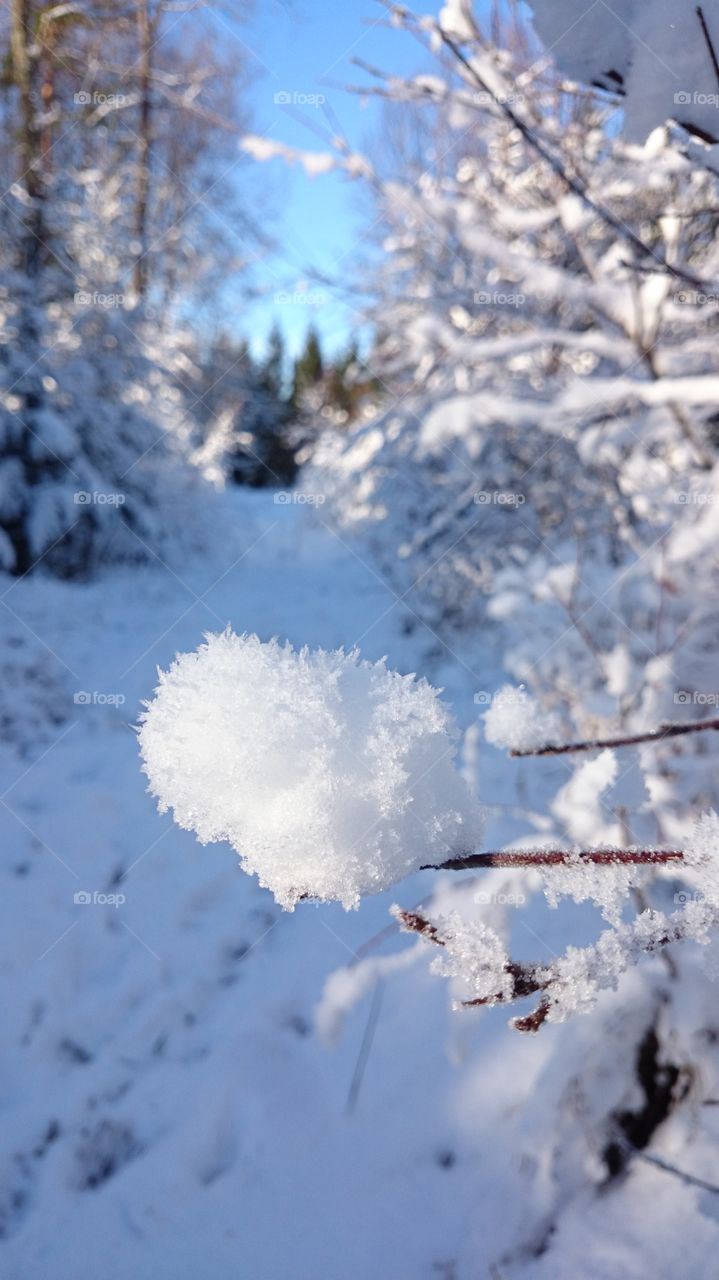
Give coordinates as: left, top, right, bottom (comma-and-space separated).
299, 5, 719, 860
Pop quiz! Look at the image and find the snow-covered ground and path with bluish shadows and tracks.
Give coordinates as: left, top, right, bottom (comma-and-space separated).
0, 492, 719, 1280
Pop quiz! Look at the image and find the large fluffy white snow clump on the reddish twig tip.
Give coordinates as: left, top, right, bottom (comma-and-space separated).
139, 628, 480, 909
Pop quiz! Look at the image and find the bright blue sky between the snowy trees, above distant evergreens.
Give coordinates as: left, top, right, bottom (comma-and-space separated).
203, 0, 440, 351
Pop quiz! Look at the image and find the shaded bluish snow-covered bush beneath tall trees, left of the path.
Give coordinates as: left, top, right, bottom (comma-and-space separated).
0, 274, 212, 577
